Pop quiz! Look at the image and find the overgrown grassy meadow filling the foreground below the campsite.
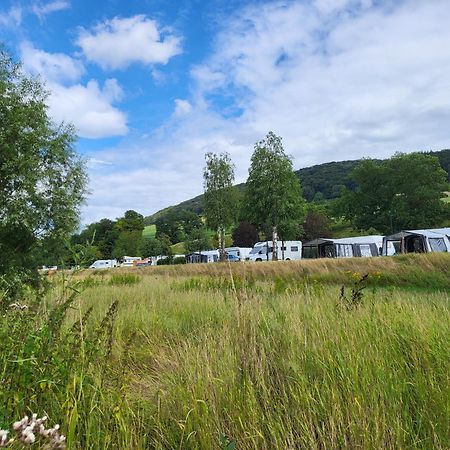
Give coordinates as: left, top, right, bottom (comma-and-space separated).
0, 254, 450, 450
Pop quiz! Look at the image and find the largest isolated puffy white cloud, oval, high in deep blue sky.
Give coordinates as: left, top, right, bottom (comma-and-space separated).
77, 15, 181, 69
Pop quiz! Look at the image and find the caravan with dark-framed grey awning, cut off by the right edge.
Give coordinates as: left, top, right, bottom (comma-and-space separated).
382, 228, 450, 256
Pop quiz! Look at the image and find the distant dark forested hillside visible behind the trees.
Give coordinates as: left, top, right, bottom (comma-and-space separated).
145, 149, 450, 225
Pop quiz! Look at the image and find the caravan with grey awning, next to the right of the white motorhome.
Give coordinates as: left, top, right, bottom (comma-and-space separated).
302, 235, 383, 259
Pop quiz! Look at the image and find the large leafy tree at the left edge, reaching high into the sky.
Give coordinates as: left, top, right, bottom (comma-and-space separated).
0, 50, 87, 292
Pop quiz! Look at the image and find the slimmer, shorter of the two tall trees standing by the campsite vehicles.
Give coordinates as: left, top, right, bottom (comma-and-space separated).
203, 153, 238, 261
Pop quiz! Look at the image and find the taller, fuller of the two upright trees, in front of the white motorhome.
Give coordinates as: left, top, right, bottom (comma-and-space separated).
245, 131, 305, 260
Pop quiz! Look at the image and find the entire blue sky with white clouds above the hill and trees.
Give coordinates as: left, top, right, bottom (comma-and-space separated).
0, 0, 450, 223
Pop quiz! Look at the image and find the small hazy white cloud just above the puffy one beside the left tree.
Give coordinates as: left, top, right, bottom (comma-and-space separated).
20, 42, 84, 81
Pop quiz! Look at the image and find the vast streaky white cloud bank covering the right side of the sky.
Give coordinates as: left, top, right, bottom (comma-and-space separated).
82, 0, 450, 222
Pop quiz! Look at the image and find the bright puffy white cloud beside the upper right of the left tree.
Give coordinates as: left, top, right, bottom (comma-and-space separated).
48, 79, 128, 139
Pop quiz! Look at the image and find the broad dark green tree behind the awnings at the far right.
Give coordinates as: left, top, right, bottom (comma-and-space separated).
337, 153, 448, 234
